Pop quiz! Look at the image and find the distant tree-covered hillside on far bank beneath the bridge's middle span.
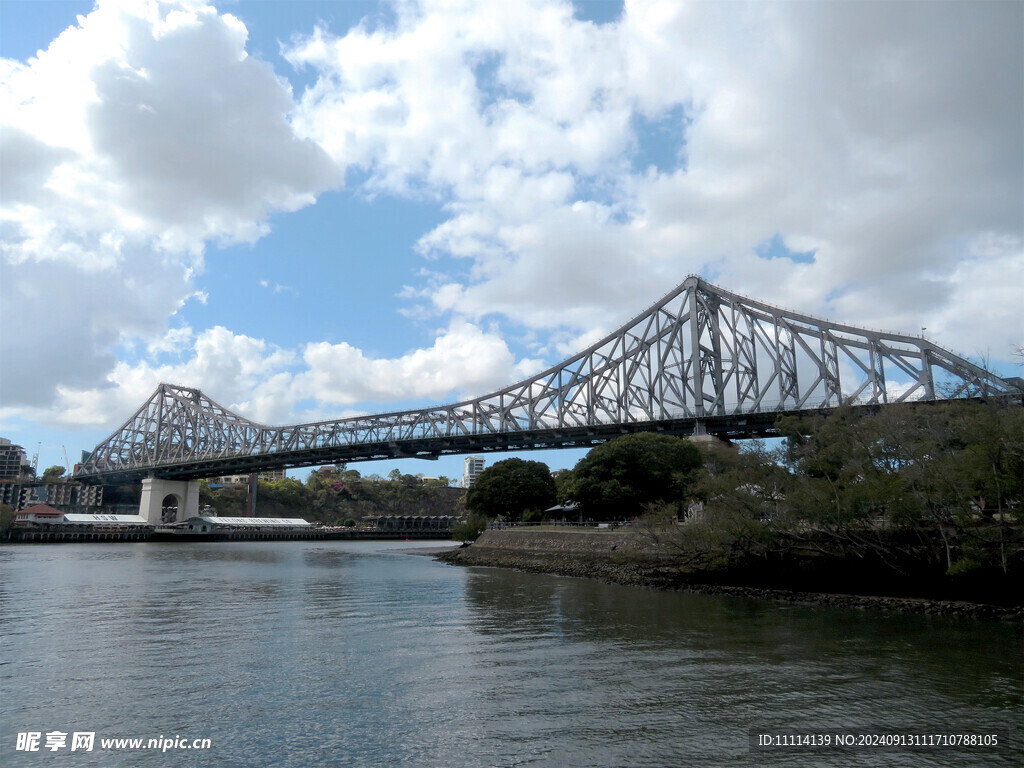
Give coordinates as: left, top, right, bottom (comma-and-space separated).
200, 468, 465, 525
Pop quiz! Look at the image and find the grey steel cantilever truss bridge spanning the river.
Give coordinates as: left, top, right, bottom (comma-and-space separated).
75, 276, 1024, 482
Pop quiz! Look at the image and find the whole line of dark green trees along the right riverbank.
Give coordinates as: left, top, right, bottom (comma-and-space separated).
459, 400, 1024, 575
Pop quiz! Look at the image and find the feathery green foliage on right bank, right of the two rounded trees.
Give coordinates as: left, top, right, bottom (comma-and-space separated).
652, 401, 1024, 575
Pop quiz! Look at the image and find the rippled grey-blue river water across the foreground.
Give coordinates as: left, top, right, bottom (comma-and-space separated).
0, 542, 1024, 768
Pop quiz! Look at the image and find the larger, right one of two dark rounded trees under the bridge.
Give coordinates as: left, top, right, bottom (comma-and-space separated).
571, 432, 703, 520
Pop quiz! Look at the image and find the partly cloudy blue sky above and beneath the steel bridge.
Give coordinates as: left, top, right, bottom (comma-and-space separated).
0, 0, 1024, 477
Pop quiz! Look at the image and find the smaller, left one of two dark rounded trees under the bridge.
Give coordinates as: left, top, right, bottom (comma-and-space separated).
466, 459, 555, 520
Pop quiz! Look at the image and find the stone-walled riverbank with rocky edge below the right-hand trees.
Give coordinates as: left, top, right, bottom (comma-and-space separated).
437, 528, 1024, 622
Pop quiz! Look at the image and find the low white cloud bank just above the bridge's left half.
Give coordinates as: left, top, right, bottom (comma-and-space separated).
16, 321, 541, 427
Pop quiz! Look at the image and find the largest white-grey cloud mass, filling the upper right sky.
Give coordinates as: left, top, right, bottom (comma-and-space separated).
290, 0, 1024, 362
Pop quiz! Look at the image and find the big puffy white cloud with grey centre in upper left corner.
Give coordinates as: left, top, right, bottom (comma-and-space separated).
0, 0, 338, 406
